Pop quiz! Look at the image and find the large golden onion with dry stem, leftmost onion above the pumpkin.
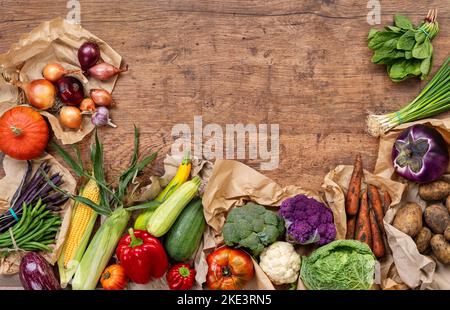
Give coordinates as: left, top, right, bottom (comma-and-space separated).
12, 79, 56, 110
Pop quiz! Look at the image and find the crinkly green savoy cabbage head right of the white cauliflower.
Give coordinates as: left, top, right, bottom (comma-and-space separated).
300, 240, 376, 290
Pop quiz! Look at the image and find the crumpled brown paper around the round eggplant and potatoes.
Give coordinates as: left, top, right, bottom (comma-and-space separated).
375, 118, 450, 290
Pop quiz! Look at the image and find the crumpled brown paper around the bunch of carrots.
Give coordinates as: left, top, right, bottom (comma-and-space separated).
322, 165, 406, 289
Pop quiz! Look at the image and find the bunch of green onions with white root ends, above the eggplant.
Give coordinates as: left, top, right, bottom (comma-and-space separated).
367, 57, 450, 137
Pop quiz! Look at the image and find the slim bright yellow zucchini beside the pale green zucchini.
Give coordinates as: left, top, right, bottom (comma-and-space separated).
134, 153, 192, 230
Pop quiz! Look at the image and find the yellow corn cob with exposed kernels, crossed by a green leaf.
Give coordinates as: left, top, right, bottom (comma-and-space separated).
58, 179, 100, 287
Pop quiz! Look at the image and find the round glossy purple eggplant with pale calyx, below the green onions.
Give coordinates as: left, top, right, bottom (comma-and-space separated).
392, 124, 449, 183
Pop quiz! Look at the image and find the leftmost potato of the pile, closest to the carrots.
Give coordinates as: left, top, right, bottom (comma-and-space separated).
393, 203, 422, 237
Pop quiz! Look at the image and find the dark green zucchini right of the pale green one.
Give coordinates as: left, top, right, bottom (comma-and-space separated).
165, 198, 206, 262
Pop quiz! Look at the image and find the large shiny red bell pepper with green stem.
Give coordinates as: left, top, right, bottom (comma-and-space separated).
116, 228, 169, 284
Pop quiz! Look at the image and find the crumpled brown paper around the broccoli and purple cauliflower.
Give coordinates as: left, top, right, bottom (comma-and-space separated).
198, 160, 345, 290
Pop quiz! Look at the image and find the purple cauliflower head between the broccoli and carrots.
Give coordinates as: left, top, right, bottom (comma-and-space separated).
279, 195, 336, 245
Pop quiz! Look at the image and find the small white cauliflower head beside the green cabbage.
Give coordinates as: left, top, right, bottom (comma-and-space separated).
259, 241, 301, 285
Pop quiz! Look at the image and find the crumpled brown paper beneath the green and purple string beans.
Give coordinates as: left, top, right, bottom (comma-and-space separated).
0, 154, 76, 275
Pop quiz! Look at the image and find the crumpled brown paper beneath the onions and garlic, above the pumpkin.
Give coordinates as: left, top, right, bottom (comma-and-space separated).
0, 18, 122, 144
